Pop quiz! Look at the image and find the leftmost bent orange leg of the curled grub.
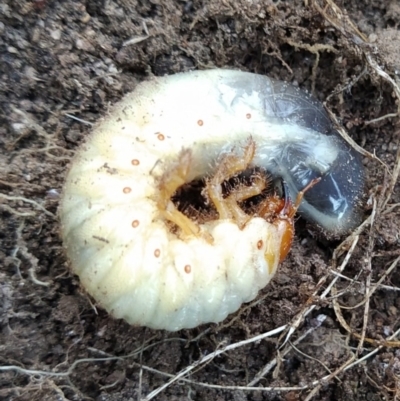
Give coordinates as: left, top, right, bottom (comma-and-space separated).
157, 149, 200, 236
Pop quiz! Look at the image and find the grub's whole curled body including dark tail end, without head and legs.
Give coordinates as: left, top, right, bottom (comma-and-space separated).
60, 69, 364, 330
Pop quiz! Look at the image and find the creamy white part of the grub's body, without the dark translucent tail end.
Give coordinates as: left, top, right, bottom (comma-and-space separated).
60, 70, 354, 330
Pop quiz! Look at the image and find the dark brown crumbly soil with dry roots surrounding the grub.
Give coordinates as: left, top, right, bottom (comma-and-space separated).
0, 0, 400, 401
